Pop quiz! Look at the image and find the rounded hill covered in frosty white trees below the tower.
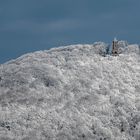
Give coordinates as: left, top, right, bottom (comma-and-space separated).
0, 42, 140, 140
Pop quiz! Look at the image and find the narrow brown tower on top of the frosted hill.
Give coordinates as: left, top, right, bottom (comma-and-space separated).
112, 38, 119, 56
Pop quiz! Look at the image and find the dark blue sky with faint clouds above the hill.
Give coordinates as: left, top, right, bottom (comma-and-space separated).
0, 0, 140, 63
